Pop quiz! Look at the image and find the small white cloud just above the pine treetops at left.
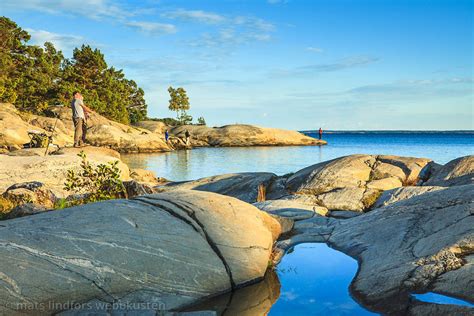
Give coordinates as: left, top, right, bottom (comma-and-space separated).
25, 28, 85, 53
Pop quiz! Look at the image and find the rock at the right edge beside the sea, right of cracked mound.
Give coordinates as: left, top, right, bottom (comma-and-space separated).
423, 155, 474, 187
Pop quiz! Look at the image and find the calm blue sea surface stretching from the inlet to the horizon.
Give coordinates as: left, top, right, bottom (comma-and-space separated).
122, 131, 474, 181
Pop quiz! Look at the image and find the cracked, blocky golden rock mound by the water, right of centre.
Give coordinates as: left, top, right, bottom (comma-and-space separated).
286, 155, 430, 212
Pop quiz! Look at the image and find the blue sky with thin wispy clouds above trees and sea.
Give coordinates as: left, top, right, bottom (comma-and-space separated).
0, 0, 474, 130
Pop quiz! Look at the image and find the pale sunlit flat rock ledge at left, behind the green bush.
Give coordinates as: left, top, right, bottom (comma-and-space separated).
0, 147, 130, 197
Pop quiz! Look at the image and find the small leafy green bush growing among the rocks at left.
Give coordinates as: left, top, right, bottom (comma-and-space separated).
64, 151, 126, 208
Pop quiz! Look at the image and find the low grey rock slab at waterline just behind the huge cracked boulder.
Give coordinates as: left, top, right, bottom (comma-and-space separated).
158, 172, 276, 203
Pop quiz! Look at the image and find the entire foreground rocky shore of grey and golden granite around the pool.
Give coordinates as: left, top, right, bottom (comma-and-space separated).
0, 147, 474, 315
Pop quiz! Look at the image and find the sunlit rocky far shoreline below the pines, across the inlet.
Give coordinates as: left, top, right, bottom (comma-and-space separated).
0, 103, 326, 153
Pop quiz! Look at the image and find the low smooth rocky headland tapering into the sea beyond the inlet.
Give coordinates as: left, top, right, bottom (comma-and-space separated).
170, 124, 326, 147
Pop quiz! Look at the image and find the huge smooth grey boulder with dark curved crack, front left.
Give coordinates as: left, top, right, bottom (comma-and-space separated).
0, 191, 280, 315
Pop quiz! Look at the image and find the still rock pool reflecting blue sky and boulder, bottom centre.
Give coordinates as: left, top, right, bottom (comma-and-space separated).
184, 244, 372, 315
